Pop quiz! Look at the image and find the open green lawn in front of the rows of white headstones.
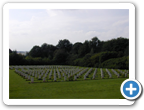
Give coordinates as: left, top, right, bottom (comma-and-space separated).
9, 69, 127, 99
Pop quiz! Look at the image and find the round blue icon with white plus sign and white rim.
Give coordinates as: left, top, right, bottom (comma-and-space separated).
121, 79, 141, 99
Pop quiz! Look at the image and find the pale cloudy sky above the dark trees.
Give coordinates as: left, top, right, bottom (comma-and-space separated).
9, 9, 129, 51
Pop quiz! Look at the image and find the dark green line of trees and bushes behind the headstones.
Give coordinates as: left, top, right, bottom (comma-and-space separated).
9, 37, 129, 69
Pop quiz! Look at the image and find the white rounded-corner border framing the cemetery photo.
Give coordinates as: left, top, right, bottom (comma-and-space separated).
3, 3, 135, 105
